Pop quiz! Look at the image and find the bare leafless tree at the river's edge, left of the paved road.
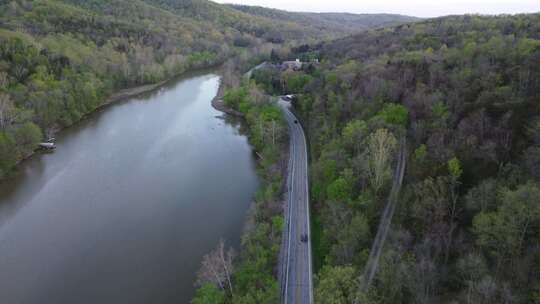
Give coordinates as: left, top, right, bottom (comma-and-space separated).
197, 239, 235, 295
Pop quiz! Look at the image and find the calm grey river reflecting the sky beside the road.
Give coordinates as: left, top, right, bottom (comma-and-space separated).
0, 74, 257, 304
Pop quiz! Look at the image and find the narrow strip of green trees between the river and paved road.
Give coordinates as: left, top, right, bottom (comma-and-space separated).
192, 74, 288, 304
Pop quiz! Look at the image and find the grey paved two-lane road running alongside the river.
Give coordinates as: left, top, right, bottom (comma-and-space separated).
279, 99, 313, 304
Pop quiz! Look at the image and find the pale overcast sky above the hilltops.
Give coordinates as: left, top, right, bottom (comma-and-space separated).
214, 0, 540, 17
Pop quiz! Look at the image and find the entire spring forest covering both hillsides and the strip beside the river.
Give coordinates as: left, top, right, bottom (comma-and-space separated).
5, 0, 540, 304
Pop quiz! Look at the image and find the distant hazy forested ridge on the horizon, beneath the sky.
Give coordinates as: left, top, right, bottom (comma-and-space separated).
226, 4, 420, 33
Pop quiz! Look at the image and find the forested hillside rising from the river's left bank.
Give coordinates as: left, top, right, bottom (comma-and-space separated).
0, 0, 416, 178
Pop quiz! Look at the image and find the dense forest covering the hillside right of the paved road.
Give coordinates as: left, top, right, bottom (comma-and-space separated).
248, 14, 540, 303
